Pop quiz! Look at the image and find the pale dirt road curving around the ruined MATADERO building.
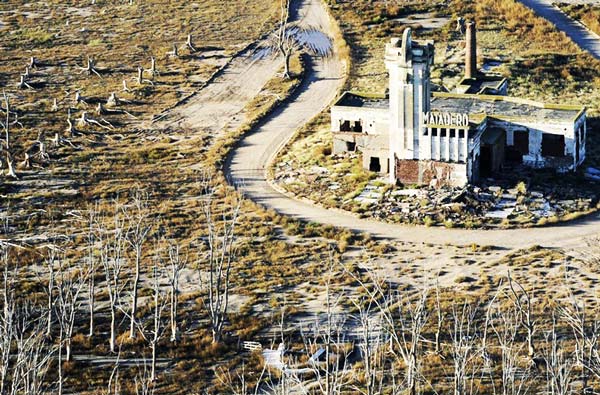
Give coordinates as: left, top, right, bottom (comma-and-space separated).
226, 0, 600, 249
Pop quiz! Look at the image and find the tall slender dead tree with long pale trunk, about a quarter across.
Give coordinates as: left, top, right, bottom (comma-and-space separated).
123, 190, 152, 339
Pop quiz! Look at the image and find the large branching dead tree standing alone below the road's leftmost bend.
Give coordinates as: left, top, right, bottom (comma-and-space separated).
198, 179, 241, 343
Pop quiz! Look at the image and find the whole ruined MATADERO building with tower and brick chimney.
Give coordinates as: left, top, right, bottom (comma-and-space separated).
331, 22, 586, 186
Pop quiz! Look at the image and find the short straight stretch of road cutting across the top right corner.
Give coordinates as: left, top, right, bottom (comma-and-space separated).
519, 0, 600, 59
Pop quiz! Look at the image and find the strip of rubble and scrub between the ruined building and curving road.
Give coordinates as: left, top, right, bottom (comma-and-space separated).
274, 154, 600, 228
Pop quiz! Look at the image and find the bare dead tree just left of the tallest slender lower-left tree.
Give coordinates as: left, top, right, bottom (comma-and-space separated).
96, 209, 125, 353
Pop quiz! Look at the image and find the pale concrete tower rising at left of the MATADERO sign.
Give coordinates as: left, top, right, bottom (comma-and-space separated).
385, 28, 434, 183
